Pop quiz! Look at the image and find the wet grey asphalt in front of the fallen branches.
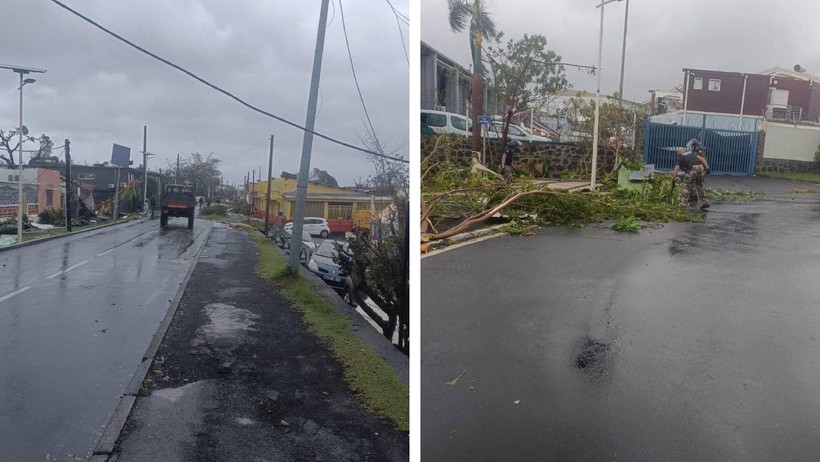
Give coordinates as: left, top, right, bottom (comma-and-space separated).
421, 178, 820, 461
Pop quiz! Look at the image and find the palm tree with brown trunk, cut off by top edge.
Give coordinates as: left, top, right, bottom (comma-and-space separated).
447, 0, 498, 151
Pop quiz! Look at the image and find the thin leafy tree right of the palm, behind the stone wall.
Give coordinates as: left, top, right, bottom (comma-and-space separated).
488, 34, 570, 143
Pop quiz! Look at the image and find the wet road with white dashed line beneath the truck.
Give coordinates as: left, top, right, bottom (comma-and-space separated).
0, 219, 212, 461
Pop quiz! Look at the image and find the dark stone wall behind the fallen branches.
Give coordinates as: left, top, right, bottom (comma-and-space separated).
421, 136, 635, 178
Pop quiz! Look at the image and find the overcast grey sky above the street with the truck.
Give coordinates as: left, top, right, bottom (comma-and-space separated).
0, 0, 409, 185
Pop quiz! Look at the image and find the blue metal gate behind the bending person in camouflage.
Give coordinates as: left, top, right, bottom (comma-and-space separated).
643, 118, 757, 175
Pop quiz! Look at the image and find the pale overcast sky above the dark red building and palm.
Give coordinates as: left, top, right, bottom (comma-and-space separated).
420, 0, 820, 102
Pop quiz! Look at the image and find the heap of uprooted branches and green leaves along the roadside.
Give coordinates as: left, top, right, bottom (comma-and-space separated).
421, 134, 762, 241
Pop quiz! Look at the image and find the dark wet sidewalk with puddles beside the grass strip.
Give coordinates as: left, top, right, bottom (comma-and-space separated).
109, 224, 409, 462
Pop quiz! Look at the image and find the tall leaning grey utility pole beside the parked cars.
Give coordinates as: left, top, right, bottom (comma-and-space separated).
289, 0, 329, 273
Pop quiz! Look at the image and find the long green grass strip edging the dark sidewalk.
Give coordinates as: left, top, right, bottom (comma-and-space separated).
243, 229, 410, 431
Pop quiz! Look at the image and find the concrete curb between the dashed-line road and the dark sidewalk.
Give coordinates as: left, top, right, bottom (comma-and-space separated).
92, 221, 213, 461
